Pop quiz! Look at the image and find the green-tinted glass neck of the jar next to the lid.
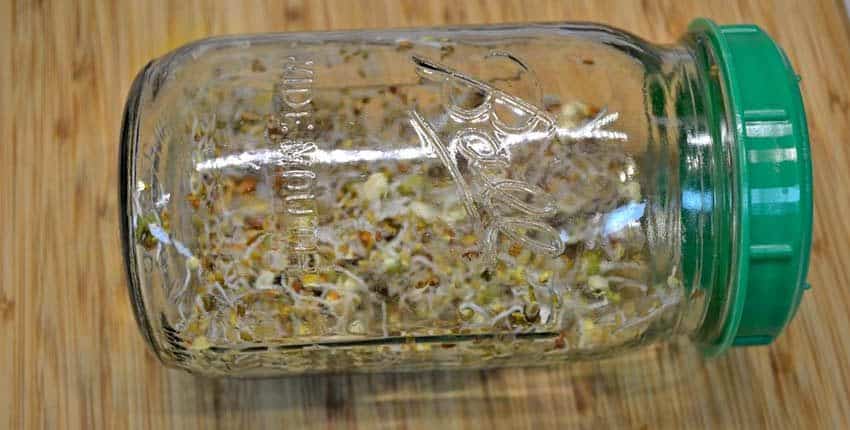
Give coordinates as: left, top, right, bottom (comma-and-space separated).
675, 37, 736, 343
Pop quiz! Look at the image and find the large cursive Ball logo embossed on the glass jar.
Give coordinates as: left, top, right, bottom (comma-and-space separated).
409, 51, 626, 256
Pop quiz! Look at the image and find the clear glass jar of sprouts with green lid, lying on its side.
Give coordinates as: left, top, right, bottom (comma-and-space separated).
120, 20, 812, 375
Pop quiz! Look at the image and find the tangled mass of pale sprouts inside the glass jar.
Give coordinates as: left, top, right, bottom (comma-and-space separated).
171, 76, 683, 368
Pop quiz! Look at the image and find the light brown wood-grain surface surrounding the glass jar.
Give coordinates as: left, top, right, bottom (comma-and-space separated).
0, 0, 850, 429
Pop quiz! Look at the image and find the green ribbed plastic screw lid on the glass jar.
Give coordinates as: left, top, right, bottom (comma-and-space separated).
689, 19, 812, 356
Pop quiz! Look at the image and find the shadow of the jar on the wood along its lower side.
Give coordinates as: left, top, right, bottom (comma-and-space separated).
152, 342, 705, 418
